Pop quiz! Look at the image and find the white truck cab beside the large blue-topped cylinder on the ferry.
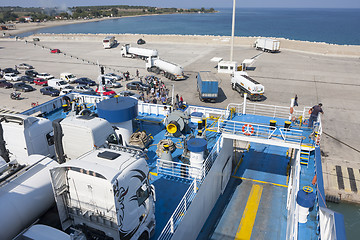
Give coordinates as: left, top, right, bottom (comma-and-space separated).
52, 116, 118, 163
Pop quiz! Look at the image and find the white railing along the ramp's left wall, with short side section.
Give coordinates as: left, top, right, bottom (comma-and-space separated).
157, 138, 222, 240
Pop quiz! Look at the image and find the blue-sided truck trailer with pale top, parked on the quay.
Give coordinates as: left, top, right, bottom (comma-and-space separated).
197, 71, 219, 102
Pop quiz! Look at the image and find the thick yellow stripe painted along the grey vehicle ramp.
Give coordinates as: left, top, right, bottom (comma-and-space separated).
235, 184, 264, 240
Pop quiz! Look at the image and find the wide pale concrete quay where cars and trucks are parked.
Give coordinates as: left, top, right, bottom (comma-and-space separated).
0, 37, 360, 202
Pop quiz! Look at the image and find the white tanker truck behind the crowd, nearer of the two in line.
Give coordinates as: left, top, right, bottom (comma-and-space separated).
146, 57, 185, 80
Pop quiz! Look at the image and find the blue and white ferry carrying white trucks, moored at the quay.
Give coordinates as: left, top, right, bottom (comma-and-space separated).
0, 93, 346, 239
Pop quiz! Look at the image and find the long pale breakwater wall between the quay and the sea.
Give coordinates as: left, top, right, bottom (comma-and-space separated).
18, 33, 360, 58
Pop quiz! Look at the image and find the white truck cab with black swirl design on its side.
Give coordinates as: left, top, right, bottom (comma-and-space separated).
50, 148, 156, 240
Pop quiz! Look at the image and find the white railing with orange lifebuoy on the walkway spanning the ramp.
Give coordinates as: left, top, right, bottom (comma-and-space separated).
218, 116, 303, 144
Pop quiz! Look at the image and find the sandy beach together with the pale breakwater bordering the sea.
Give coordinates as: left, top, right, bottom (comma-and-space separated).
0, 13, 360, 58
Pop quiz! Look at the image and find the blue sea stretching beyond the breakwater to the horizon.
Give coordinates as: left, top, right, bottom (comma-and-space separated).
22, 8, 360, 45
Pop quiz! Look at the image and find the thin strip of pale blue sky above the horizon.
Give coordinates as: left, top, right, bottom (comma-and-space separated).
0, 0, 360, 8
